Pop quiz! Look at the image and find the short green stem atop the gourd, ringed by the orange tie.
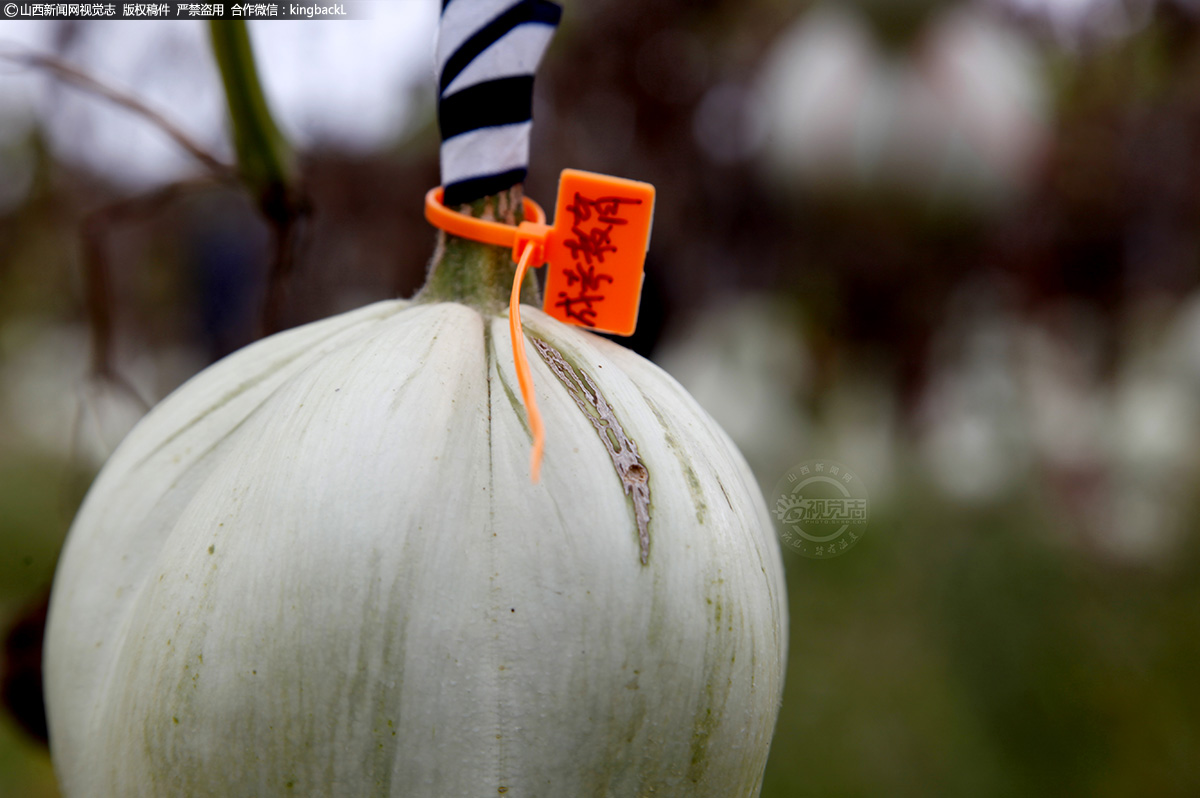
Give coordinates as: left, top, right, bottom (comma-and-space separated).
416, 185, 541, 316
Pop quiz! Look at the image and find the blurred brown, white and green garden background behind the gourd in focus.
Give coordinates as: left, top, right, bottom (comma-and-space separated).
0, 0, 1200, 798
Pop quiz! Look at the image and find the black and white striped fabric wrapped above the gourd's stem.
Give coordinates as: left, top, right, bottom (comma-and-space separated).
437, 0, 563, 206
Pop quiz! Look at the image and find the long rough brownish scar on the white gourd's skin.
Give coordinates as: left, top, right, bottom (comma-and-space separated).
529, 336, 650, 565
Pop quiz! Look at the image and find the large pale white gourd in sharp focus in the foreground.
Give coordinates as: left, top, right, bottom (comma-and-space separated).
46, 291, 787, 798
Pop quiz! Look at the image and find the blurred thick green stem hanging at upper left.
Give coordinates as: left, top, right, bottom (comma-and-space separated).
209, 20, 292, 199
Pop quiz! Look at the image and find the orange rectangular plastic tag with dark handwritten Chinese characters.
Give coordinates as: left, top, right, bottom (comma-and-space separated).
542, 169, 654, 335
